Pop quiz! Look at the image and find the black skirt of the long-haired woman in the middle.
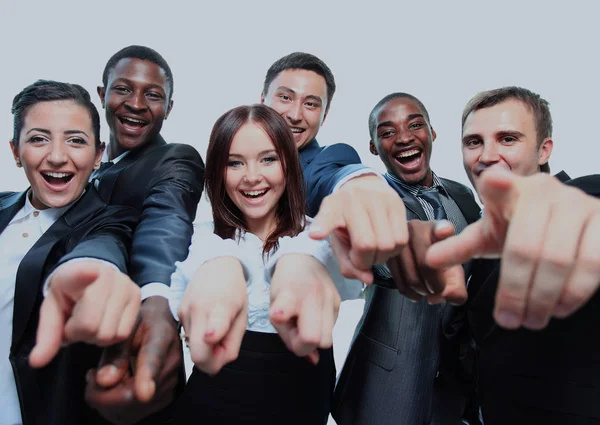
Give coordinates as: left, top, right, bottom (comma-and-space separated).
174, 331, 335, 425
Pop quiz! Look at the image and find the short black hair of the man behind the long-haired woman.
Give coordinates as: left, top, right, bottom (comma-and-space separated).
263, 52, 335, 112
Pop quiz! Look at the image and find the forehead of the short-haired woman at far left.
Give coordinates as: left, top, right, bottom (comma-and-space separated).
23, 100, 92, 131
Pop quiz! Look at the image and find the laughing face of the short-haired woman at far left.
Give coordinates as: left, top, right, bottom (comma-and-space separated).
10, 100, 103, 209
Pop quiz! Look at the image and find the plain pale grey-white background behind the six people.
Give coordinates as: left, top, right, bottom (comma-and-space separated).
0, 0, 600, 420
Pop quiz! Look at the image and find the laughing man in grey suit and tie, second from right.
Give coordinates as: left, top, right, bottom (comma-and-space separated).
333, 93, 480, 425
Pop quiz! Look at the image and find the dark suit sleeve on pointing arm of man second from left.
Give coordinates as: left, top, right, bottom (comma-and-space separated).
129, 144, 204, 287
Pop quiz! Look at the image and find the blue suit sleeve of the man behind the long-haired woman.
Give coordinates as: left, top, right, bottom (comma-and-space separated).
304, 143, 369, 217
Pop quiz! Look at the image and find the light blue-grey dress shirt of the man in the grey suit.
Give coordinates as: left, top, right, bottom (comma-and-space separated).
375, 172, 467, 279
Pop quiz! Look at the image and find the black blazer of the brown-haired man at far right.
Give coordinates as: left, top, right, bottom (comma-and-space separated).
467, 173, 600, 425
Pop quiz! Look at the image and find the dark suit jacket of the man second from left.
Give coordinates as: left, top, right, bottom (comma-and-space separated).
98, 135, 204, 287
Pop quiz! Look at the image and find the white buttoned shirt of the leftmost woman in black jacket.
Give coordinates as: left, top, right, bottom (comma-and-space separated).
0, 194, 70, 425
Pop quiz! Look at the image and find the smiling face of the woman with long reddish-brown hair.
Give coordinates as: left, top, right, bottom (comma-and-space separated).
225, 122, 286, 236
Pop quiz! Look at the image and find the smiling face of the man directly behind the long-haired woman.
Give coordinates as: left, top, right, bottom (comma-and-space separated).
261, 69, 327, 150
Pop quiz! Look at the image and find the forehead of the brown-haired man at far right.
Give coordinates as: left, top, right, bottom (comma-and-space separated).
463, 99, 536, 137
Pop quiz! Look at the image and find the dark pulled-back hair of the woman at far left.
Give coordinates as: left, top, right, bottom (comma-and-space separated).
11, 80, 101, 149
